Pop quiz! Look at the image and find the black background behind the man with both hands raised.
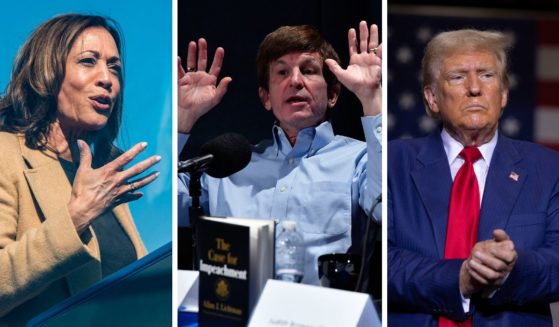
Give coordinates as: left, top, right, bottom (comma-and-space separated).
178, 0, 382, 156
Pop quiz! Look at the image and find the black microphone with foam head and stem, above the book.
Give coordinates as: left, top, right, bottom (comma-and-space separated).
178, 133, 252, 178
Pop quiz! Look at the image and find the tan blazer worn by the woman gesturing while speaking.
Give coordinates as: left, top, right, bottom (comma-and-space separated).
0, 132, 146, 327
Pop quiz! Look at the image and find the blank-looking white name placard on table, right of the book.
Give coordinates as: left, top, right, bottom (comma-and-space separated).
249, 279, 381, 327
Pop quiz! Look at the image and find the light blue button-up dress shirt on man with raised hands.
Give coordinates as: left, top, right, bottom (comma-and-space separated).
178, 114, 382, 284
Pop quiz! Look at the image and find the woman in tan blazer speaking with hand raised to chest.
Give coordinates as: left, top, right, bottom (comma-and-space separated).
0, 14, 160, 326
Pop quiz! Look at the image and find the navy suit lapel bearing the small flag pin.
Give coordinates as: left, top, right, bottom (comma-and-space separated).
478, 135, 528, 240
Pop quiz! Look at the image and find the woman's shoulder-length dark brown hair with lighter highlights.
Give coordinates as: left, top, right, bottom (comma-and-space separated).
0, 14, 124, 165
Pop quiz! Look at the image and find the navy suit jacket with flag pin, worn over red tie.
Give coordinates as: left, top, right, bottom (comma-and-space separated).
388, 132, 559, 327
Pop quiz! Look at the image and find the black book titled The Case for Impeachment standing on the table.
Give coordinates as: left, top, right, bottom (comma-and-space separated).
196, 216, 275, 326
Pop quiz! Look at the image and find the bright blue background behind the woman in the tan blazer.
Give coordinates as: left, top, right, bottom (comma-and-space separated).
0, 0, 173, 251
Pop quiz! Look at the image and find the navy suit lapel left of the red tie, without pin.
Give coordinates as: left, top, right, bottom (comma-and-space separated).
411, 133, 452, 258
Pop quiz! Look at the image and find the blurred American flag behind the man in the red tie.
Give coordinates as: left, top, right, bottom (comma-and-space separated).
387, 7, 559, 150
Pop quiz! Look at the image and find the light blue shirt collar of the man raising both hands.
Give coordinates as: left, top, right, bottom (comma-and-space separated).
272, 121, 334, 157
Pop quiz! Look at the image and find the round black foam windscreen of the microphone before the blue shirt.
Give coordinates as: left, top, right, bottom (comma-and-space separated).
200, 133, 252, 178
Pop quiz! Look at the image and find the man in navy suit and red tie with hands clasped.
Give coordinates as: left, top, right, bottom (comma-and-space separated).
388, 30, 559, 327
